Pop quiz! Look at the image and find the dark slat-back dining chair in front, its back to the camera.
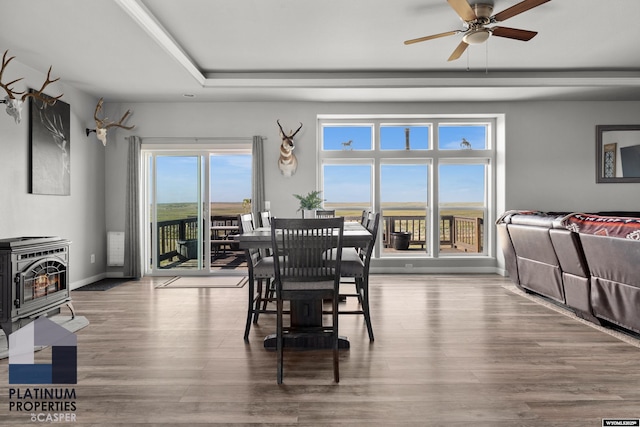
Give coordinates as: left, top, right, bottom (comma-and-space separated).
271, 217, 344, 384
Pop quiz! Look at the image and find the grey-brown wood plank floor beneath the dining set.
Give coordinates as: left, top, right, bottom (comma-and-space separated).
0, 275, 640, 427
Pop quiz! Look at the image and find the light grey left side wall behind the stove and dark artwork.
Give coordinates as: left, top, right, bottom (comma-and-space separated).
0, 60, 106, 288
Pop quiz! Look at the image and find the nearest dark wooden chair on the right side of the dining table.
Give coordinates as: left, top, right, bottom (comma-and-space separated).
332, 212, 380, 341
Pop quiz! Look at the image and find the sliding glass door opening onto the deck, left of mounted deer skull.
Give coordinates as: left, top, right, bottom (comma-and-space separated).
145, 148, 251, 275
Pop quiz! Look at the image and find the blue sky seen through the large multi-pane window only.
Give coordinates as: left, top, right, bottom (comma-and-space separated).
323, 125, 487, 204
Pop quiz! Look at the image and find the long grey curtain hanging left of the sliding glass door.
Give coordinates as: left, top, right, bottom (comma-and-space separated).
124, 136, 142, 279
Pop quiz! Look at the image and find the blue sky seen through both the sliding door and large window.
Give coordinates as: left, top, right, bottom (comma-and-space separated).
152, 125, 487, 205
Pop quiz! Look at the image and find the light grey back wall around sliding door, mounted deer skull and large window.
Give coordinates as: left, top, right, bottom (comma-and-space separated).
106, 98, 640, 271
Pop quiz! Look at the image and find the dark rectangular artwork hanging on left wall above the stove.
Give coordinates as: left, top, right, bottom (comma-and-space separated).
29, 91, 71, 196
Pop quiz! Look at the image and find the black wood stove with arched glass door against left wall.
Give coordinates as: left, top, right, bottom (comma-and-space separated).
0, 237, 75, 337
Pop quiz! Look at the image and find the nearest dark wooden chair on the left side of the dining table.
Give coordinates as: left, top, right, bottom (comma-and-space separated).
238, 213, 275, 341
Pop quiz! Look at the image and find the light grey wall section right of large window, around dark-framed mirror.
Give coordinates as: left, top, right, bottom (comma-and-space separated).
506, 102, 640, 212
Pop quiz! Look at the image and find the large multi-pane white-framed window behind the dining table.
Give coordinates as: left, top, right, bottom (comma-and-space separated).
318, 116, 495, 258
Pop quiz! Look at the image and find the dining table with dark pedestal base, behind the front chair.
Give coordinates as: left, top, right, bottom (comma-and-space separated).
235, 221, 373, 350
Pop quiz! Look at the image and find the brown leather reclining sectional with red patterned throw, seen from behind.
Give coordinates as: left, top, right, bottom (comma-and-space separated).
497, 211, 640, 334
